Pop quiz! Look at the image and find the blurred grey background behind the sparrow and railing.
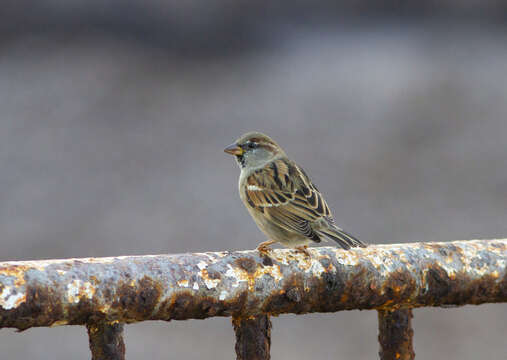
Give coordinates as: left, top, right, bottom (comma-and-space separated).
0, 0, 507, 360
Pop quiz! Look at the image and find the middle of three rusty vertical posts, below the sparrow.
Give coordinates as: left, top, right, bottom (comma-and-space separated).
232, 315, 271, 360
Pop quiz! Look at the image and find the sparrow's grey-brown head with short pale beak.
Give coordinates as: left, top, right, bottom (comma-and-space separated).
224, 132, 285, 168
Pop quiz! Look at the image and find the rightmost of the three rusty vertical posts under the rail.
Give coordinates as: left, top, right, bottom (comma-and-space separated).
378, 309, 415, 360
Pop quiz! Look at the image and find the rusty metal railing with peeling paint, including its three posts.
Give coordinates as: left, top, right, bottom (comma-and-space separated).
0, 239, 507, 360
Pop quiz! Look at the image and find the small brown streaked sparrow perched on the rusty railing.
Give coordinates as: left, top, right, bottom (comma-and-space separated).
224, 132, 366, 255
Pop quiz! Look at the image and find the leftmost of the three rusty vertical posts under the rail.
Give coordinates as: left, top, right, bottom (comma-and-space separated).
86, 322, 125, 360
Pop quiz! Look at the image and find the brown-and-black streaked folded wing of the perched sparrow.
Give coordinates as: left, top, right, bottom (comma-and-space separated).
244, 158, 334, 241
